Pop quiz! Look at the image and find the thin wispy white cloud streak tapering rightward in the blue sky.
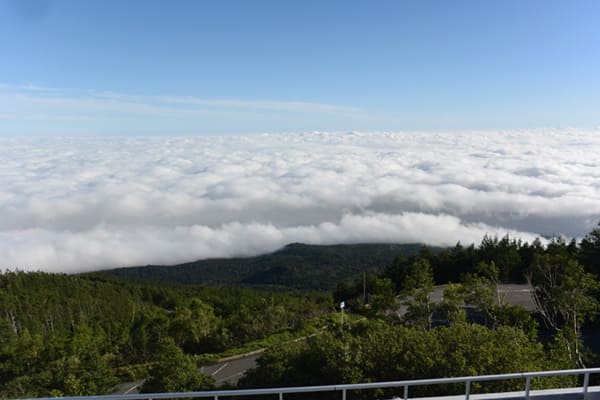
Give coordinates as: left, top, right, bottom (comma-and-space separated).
0, 84, 390, 136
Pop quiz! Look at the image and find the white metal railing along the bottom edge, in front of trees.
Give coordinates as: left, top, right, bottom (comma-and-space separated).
16, 368, 600, 400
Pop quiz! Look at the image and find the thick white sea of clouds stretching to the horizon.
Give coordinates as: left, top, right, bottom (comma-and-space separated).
0, 129, 600, 272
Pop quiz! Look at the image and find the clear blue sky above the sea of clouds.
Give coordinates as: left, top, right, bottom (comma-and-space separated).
0, 0, 600, 135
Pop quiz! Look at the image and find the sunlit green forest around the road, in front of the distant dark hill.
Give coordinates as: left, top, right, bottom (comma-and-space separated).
0, 224, 600, 398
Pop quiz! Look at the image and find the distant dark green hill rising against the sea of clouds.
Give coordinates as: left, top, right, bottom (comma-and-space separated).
101, 243, 422, 290
